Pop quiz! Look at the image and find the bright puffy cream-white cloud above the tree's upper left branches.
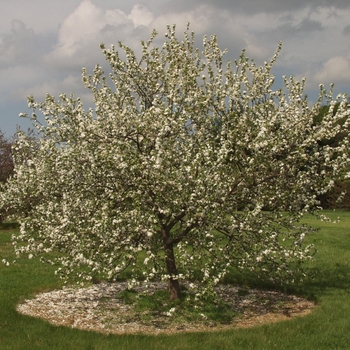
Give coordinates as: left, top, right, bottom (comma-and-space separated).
44, 0, 154, 72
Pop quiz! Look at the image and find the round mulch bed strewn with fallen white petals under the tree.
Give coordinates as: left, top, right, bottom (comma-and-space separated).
17, 282, 315, 334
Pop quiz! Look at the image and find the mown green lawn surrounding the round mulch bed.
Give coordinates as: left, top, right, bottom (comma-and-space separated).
0, 211, 350, 350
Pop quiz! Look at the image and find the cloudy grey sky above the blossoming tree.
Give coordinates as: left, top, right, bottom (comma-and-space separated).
0, 0, 350, 136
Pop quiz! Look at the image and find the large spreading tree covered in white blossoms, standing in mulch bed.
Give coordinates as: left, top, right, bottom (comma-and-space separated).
1, 26, 349, 299
